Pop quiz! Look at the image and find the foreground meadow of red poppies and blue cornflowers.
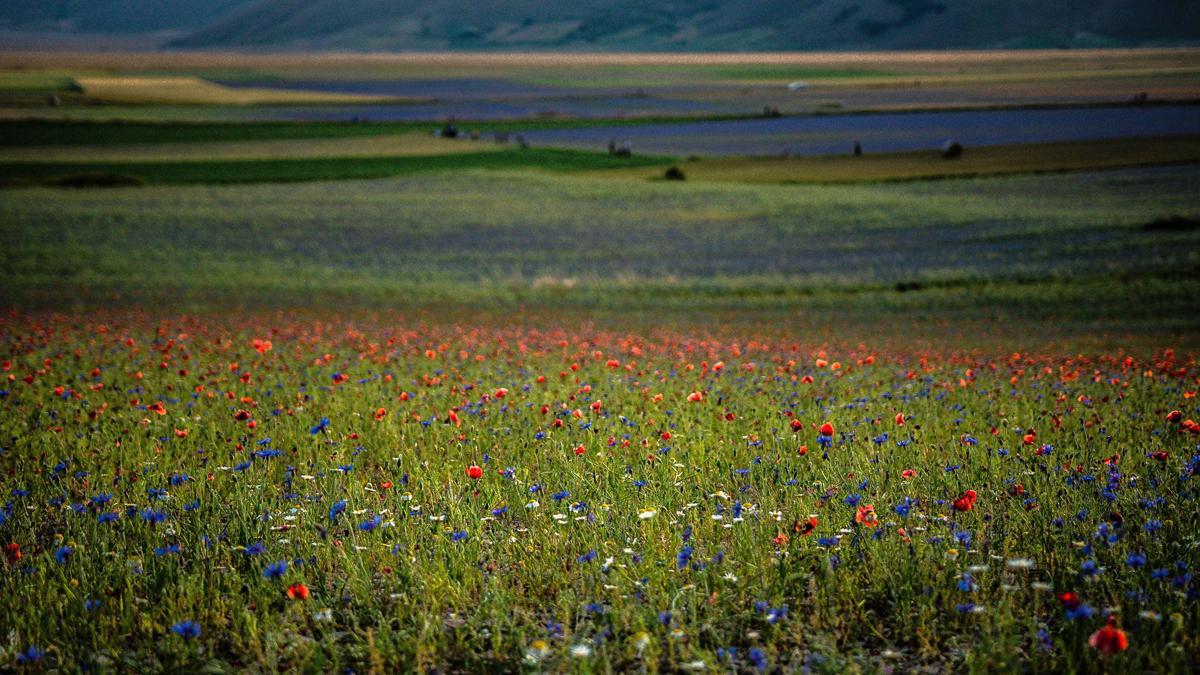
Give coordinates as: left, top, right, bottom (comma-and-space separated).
0, 311, 1200, 673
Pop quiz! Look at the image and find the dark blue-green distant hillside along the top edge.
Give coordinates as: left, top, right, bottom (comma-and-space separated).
0, 0, 1200, 50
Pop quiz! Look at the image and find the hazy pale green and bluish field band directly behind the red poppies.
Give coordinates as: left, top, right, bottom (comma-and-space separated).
0, 165, 1200, 339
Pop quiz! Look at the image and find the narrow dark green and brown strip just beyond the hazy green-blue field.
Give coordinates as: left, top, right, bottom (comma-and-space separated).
0, 132, 1200, 184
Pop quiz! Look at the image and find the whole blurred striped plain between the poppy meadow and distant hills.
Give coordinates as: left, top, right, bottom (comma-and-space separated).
0, 49, 1200, 353
